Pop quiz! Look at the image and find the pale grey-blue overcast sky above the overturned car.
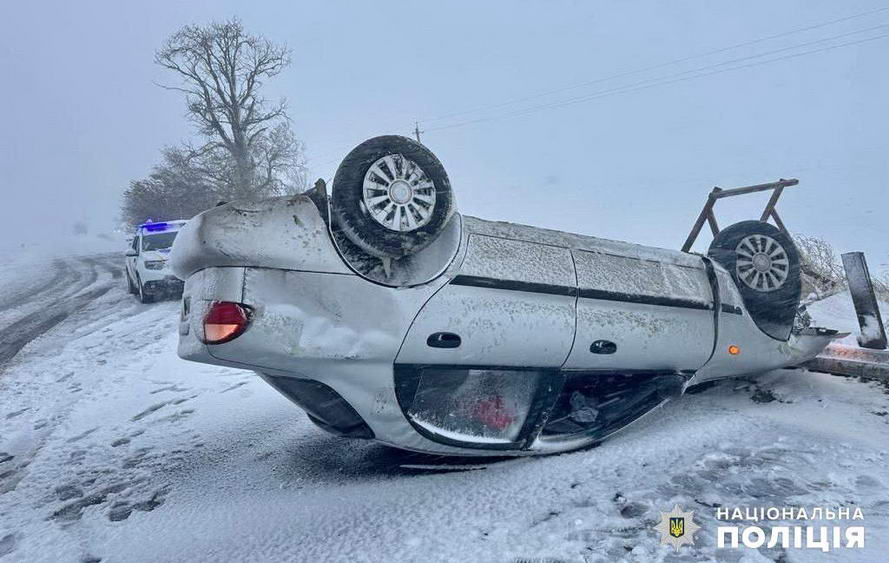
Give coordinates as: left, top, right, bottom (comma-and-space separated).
0, 0, 889, 268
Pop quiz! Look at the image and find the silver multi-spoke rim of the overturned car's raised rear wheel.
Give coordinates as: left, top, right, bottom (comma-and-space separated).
362, 153, 435, 233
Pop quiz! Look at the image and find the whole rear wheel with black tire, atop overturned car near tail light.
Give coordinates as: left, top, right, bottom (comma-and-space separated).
331, 135, 454, 259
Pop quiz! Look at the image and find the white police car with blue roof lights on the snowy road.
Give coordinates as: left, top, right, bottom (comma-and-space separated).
126, 220, 186, 303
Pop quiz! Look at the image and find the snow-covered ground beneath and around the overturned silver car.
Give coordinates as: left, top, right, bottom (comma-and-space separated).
0, 255, 889, 563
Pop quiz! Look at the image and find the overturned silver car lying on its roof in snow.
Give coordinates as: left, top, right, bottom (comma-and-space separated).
172, 136, 835, 455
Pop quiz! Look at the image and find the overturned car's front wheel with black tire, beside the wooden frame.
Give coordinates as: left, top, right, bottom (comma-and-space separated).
707, 221, 801, 340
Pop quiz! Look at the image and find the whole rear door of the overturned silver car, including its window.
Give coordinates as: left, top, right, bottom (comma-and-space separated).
394, 234, 577, 449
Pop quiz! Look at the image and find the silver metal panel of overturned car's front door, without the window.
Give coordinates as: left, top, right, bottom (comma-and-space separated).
565, 250, 715, 371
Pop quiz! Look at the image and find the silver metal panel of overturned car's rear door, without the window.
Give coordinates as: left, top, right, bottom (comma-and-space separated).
397, 234, 576, 368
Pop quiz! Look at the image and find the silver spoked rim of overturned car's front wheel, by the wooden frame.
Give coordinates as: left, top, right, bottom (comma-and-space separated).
735, 235, 790, 292
